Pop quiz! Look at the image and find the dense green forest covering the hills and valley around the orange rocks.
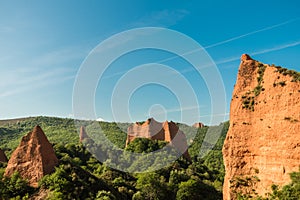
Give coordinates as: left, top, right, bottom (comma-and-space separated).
0, 117, 300, 200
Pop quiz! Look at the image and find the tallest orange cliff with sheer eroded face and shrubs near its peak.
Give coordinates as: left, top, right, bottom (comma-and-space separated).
223, 54, 300, 200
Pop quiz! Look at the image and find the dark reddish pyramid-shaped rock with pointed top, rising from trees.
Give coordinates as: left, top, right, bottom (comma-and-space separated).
4, 126, 58, 187
